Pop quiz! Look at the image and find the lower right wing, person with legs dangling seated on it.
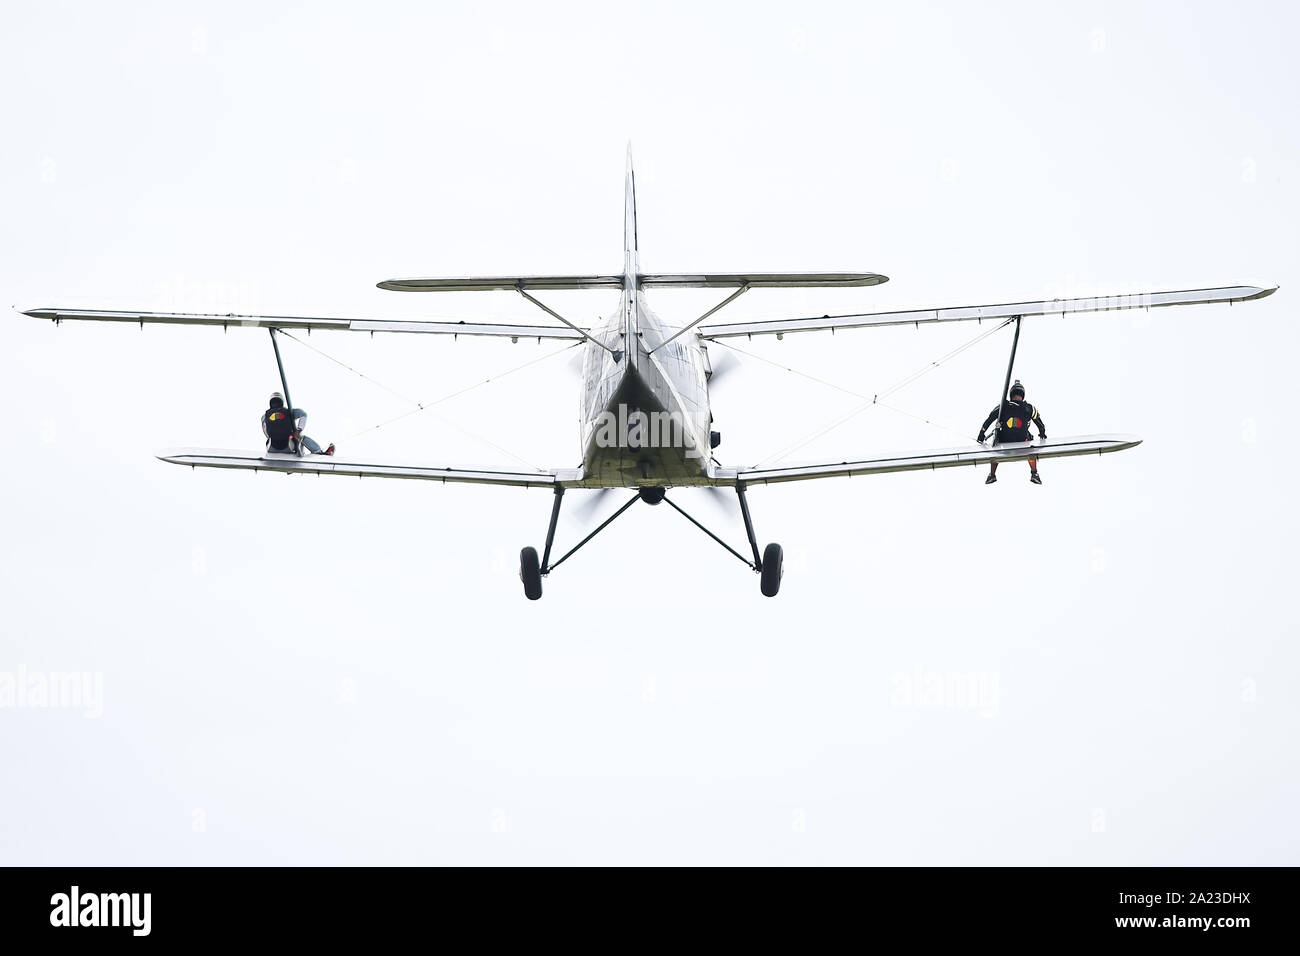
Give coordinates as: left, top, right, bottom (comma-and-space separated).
715, 434, 1141, 485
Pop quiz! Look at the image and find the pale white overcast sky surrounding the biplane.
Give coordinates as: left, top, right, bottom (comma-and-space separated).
0, 3, 1300, 865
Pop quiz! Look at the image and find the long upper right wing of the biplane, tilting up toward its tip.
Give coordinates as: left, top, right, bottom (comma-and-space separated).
699, 285, 1277, 339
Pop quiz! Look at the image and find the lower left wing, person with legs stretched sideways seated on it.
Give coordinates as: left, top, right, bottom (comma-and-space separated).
159, 449, 580, 488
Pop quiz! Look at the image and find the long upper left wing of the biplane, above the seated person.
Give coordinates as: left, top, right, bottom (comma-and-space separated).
23, 308, 584, 341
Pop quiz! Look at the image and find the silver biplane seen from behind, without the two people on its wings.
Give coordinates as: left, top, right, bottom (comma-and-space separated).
26, 148, 1275, 601
